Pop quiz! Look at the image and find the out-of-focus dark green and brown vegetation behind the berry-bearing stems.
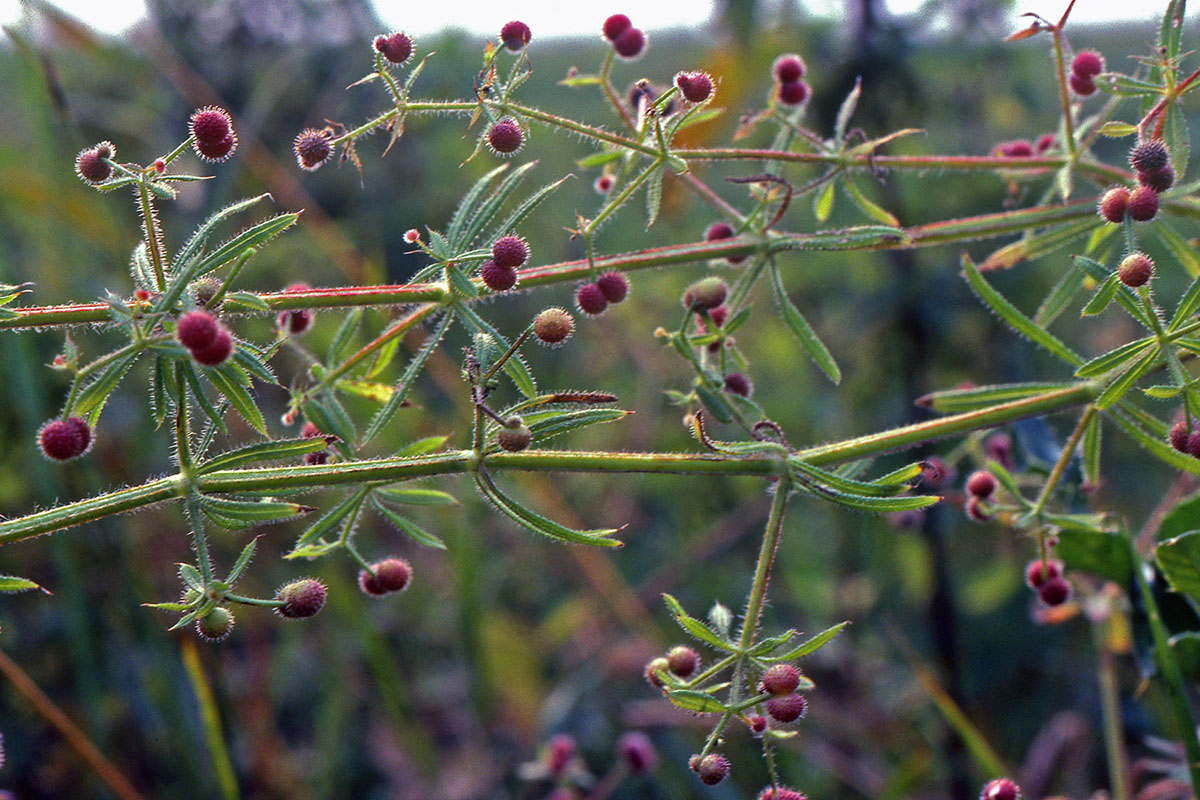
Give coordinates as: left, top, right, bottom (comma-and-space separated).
0, 0, 1192, 800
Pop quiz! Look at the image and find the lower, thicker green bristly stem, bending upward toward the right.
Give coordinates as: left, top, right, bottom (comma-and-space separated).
0, 381, 1102, 546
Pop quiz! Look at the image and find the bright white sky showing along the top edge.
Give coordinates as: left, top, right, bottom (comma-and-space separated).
0, 0, 1163, 37
